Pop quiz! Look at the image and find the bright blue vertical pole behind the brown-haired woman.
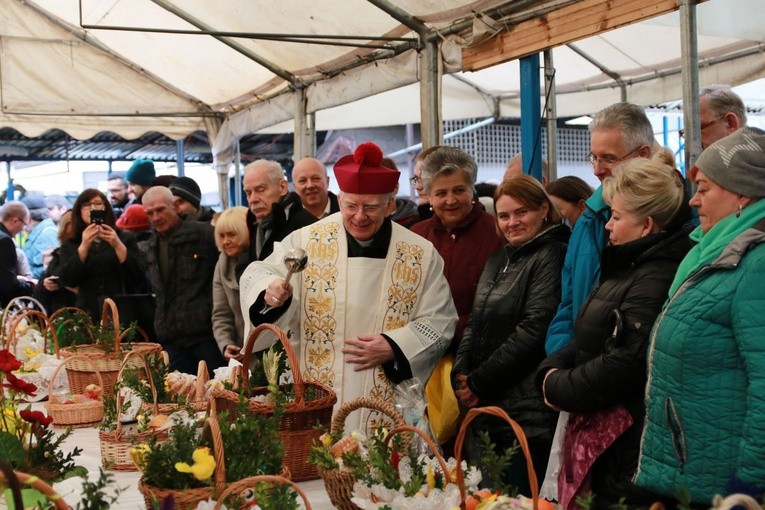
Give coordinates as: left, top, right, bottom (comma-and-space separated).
521, 53, 542, 182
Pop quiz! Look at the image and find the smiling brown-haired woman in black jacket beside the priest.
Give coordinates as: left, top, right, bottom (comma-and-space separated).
452, 175, 570, 495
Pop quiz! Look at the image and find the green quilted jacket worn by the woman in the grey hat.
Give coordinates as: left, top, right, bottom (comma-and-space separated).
635, 215, 765, 505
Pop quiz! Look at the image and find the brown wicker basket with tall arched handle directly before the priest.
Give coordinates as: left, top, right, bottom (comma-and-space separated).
213, 324, 337, 481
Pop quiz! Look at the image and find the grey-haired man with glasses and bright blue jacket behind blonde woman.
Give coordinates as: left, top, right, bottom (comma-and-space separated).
545, 103, 655, 354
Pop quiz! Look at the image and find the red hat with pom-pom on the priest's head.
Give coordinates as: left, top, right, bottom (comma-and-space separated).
335, 142, 401, 195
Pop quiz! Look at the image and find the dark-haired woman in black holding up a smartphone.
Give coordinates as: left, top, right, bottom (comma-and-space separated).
59, 188, 146, 320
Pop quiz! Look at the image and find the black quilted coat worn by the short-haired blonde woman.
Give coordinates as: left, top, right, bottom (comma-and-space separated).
537, 229, 691, 504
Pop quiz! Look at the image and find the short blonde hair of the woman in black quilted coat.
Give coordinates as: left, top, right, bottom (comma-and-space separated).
603, 148, 685, 229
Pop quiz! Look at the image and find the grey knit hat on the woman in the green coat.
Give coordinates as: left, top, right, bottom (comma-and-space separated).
690, 127, 765, 198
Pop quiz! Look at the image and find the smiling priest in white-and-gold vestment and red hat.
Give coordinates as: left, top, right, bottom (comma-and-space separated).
239, 142, 457, 430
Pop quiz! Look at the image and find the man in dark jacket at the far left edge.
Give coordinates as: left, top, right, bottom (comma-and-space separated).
0, 200, 35, 307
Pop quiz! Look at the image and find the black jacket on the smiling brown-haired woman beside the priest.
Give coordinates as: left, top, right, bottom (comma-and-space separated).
452, 225, 570, 441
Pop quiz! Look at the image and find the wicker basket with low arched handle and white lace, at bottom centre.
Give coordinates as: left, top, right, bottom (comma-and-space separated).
317, 397, 406, 510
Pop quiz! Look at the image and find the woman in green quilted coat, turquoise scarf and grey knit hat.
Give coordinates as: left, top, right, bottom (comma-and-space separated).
635, 128, 765, 507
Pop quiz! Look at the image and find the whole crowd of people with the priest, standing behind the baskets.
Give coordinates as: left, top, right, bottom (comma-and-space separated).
0, 85, 765, 510
